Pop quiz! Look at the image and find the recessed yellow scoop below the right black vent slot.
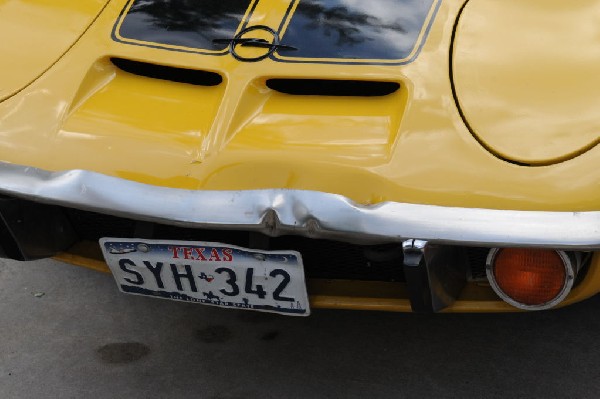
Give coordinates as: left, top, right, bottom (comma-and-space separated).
229, 80, 407, 159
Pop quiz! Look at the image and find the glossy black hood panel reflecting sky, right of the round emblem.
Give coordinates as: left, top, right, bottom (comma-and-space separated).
282, 0, 434, 60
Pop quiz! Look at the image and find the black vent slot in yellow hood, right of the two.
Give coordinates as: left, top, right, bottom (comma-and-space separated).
267, 79, 400, 97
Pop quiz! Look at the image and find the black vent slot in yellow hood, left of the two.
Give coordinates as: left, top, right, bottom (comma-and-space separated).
111, 58, 223, 86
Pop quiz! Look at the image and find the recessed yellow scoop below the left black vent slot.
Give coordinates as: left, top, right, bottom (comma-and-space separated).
55, 60, 224, 178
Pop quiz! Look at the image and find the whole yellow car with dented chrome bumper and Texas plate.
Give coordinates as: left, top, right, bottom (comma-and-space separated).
0, 0, 600, 315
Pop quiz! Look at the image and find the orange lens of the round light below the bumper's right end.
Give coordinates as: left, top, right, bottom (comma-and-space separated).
491, 248, 569, 306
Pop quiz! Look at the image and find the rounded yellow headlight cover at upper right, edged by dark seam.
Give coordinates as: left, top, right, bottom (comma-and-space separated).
453, 0, 600, 164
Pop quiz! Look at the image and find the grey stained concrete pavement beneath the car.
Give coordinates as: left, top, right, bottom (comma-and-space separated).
0, 260, 600, 399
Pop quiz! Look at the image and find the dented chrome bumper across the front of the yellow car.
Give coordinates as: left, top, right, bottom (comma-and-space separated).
0, 163, 600, 250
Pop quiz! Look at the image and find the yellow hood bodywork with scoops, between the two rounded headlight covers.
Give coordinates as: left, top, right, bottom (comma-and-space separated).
0, 0, 600, 211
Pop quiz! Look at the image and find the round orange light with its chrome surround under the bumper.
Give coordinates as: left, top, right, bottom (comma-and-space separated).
486, 248, 581, 310
